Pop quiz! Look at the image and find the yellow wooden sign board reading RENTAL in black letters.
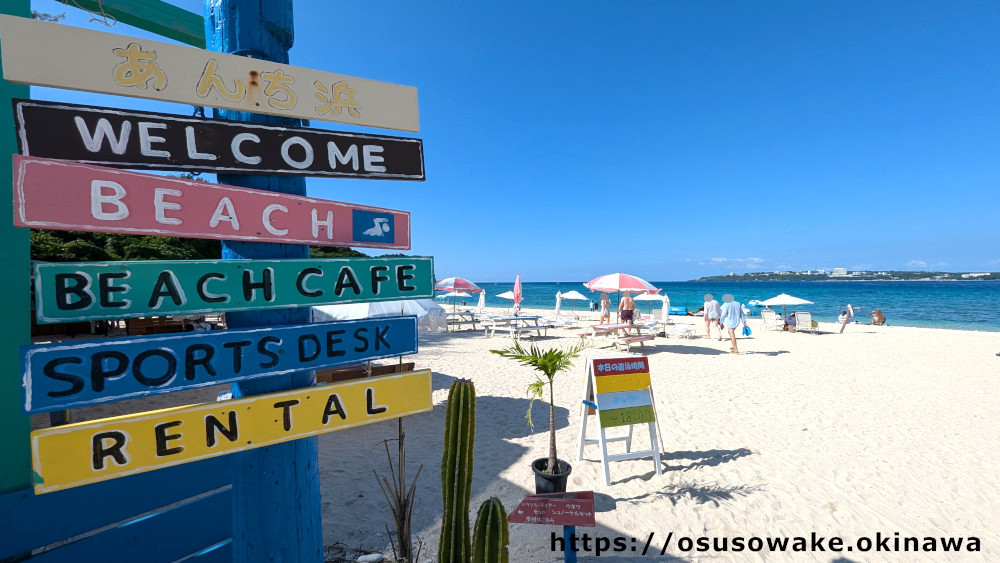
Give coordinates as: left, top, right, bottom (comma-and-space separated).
31, 370, 432, 494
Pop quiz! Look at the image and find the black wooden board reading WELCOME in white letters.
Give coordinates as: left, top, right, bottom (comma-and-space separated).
14, 100, 424, 180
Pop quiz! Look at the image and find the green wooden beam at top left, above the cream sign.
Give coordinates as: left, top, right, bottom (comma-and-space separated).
66, 0, 205, 49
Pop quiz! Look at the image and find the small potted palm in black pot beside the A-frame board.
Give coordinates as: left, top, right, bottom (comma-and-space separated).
490, 341, 584, 494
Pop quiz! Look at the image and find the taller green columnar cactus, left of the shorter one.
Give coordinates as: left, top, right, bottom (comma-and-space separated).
438, 379, 476, 563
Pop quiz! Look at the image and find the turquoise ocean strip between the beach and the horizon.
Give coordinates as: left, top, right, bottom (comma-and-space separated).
448, 281, 1000, 332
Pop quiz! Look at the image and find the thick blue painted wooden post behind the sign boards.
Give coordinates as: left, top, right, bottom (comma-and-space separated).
205, 0, 323, 561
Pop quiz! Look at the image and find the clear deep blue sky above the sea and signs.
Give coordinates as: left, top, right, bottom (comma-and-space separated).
32, 0, 1000, 281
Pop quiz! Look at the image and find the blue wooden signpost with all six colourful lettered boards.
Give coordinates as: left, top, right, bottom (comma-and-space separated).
0, 0, 433, 561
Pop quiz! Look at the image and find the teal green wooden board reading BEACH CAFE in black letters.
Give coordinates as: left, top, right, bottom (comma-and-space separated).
35, 257, 434, 323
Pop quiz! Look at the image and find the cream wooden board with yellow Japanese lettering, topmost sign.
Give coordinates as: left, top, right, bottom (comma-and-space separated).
0, 16, 420, 131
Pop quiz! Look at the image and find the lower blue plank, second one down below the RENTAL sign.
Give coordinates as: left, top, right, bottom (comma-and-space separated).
31, 488, 233, 563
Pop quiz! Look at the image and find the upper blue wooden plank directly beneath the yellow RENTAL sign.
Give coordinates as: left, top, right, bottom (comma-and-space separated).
0, 456, 233, 559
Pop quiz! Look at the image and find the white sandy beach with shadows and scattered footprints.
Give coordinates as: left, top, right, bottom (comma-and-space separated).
35, 311, 1000, 562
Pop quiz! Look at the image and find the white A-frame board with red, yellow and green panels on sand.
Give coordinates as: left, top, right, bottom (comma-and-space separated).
576, 356, 662, 485
